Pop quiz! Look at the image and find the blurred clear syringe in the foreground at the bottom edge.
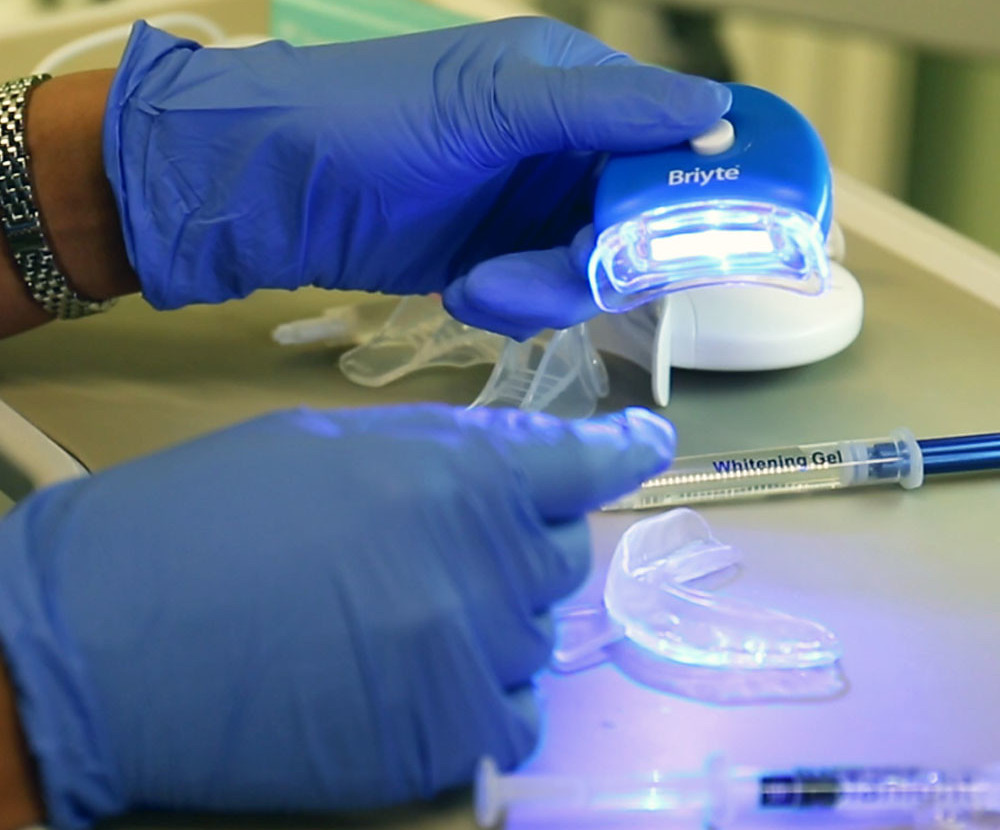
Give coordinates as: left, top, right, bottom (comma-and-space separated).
476, 755, 1000, 830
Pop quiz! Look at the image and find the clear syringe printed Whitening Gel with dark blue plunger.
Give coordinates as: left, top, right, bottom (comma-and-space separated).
601, 427, 1000, 511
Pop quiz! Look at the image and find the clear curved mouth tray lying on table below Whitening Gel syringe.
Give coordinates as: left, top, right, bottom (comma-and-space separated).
553, 508, 841, 671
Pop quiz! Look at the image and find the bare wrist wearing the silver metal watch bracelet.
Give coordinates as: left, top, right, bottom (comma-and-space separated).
0, 70, 138, 337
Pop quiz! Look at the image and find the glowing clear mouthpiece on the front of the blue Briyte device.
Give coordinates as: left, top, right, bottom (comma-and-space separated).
588, 199, 830, 312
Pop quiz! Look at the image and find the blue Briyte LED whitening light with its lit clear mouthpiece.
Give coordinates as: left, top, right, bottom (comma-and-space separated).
588, 84, 833, 311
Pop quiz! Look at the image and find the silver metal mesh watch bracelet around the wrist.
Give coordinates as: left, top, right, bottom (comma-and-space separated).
0, 75, 114, 320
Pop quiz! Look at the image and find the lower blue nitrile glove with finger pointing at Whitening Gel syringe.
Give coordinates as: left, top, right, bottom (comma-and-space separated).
0, 405, 674, 828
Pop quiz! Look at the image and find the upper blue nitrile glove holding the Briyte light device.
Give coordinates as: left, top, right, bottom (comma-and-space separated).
104, 18, 730, 337
